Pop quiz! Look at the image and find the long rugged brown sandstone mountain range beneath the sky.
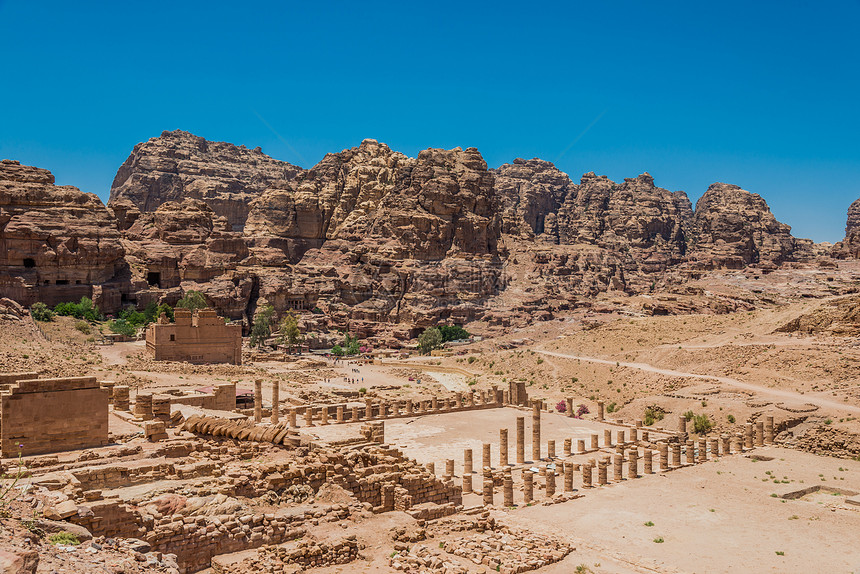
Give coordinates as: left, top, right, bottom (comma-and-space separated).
0, 131, 832, 339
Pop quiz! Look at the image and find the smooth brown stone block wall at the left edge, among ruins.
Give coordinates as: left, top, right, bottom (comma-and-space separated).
0, 373, 111, 458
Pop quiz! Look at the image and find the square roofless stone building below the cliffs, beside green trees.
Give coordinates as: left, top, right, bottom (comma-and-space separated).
146, 309, 242, 365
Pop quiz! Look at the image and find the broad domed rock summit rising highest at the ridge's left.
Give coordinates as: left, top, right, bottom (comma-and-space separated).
109, 130, 302, 230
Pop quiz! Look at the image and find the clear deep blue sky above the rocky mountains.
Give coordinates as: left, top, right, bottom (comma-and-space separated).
0, 0, 860, 241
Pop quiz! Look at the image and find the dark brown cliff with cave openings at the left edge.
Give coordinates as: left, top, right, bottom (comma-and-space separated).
0, 160, 127, 311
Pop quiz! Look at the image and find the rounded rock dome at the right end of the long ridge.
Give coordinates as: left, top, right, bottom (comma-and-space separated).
692, 183, 797, 269
